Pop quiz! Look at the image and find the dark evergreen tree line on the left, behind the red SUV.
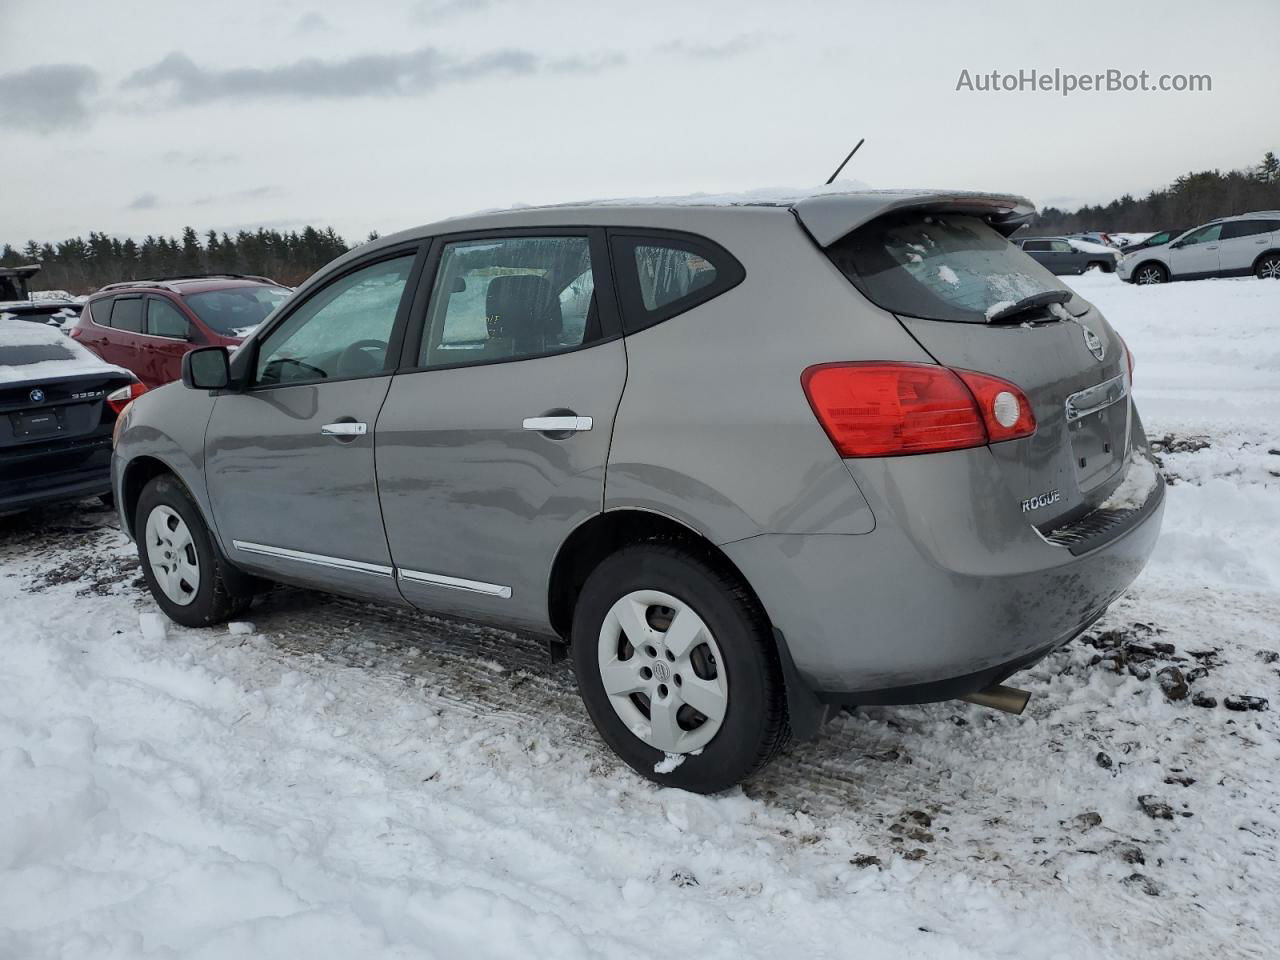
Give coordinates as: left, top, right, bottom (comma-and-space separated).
0, 227, 378, 293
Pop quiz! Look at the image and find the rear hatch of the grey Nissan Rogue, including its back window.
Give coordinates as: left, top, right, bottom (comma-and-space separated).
827, 209, 1132, 530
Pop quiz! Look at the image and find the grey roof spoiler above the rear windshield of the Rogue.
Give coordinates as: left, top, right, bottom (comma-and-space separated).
791, 191, 1036, 247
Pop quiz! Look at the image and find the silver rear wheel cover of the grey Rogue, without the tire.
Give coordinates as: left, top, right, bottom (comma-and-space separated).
599, 590, 728, 754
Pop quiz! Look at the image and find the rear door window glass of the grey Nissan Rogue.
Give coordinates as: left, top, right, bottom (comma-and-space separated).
417, 237, 600, 367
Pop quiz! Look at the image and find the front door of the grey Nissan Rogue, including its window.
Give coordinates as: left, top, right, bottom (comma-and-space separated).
205, 246, 417, 599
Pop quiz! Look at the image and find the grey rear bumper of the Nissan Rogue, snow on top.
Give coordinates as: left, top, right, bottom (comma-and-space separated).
722, 455, 1164, 704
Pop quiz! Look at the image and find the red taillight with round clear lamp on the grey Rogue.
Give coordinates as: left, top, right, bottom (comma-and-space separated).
800, 362, 1036, 457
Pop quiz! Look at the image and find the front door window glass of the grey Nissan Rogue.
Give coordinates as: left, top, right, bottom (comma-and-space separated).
256, 253, 413, 387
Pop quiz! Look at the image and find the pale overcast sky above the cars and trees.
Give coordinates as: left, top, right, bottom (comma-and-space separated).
0, 0, 1280, 244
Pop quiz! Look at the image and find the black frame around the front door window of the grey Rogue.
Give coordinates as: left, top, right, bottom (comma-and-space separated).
240, 237, 431, 393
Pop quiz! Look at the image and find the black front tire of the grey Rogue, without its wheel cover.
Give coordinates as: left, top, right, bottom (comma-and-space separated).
133, 474, 253, 627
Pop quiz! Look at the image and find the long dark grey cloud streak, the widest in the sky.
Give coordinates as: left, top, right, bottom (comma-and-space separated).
123, 47, 626, 105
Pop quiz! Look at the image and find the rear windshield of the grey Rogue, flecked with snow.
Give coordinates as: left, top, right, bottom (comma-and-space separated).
827, 214, 1088, 324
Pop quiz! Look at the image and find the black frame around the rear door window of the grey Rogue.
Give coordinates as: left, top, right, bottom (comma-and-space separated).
396, 225, 622, 375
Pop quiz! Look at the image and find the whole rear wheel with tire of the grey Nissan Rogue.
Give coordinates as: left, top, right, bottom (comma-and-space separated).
571, 544, 788, 794
